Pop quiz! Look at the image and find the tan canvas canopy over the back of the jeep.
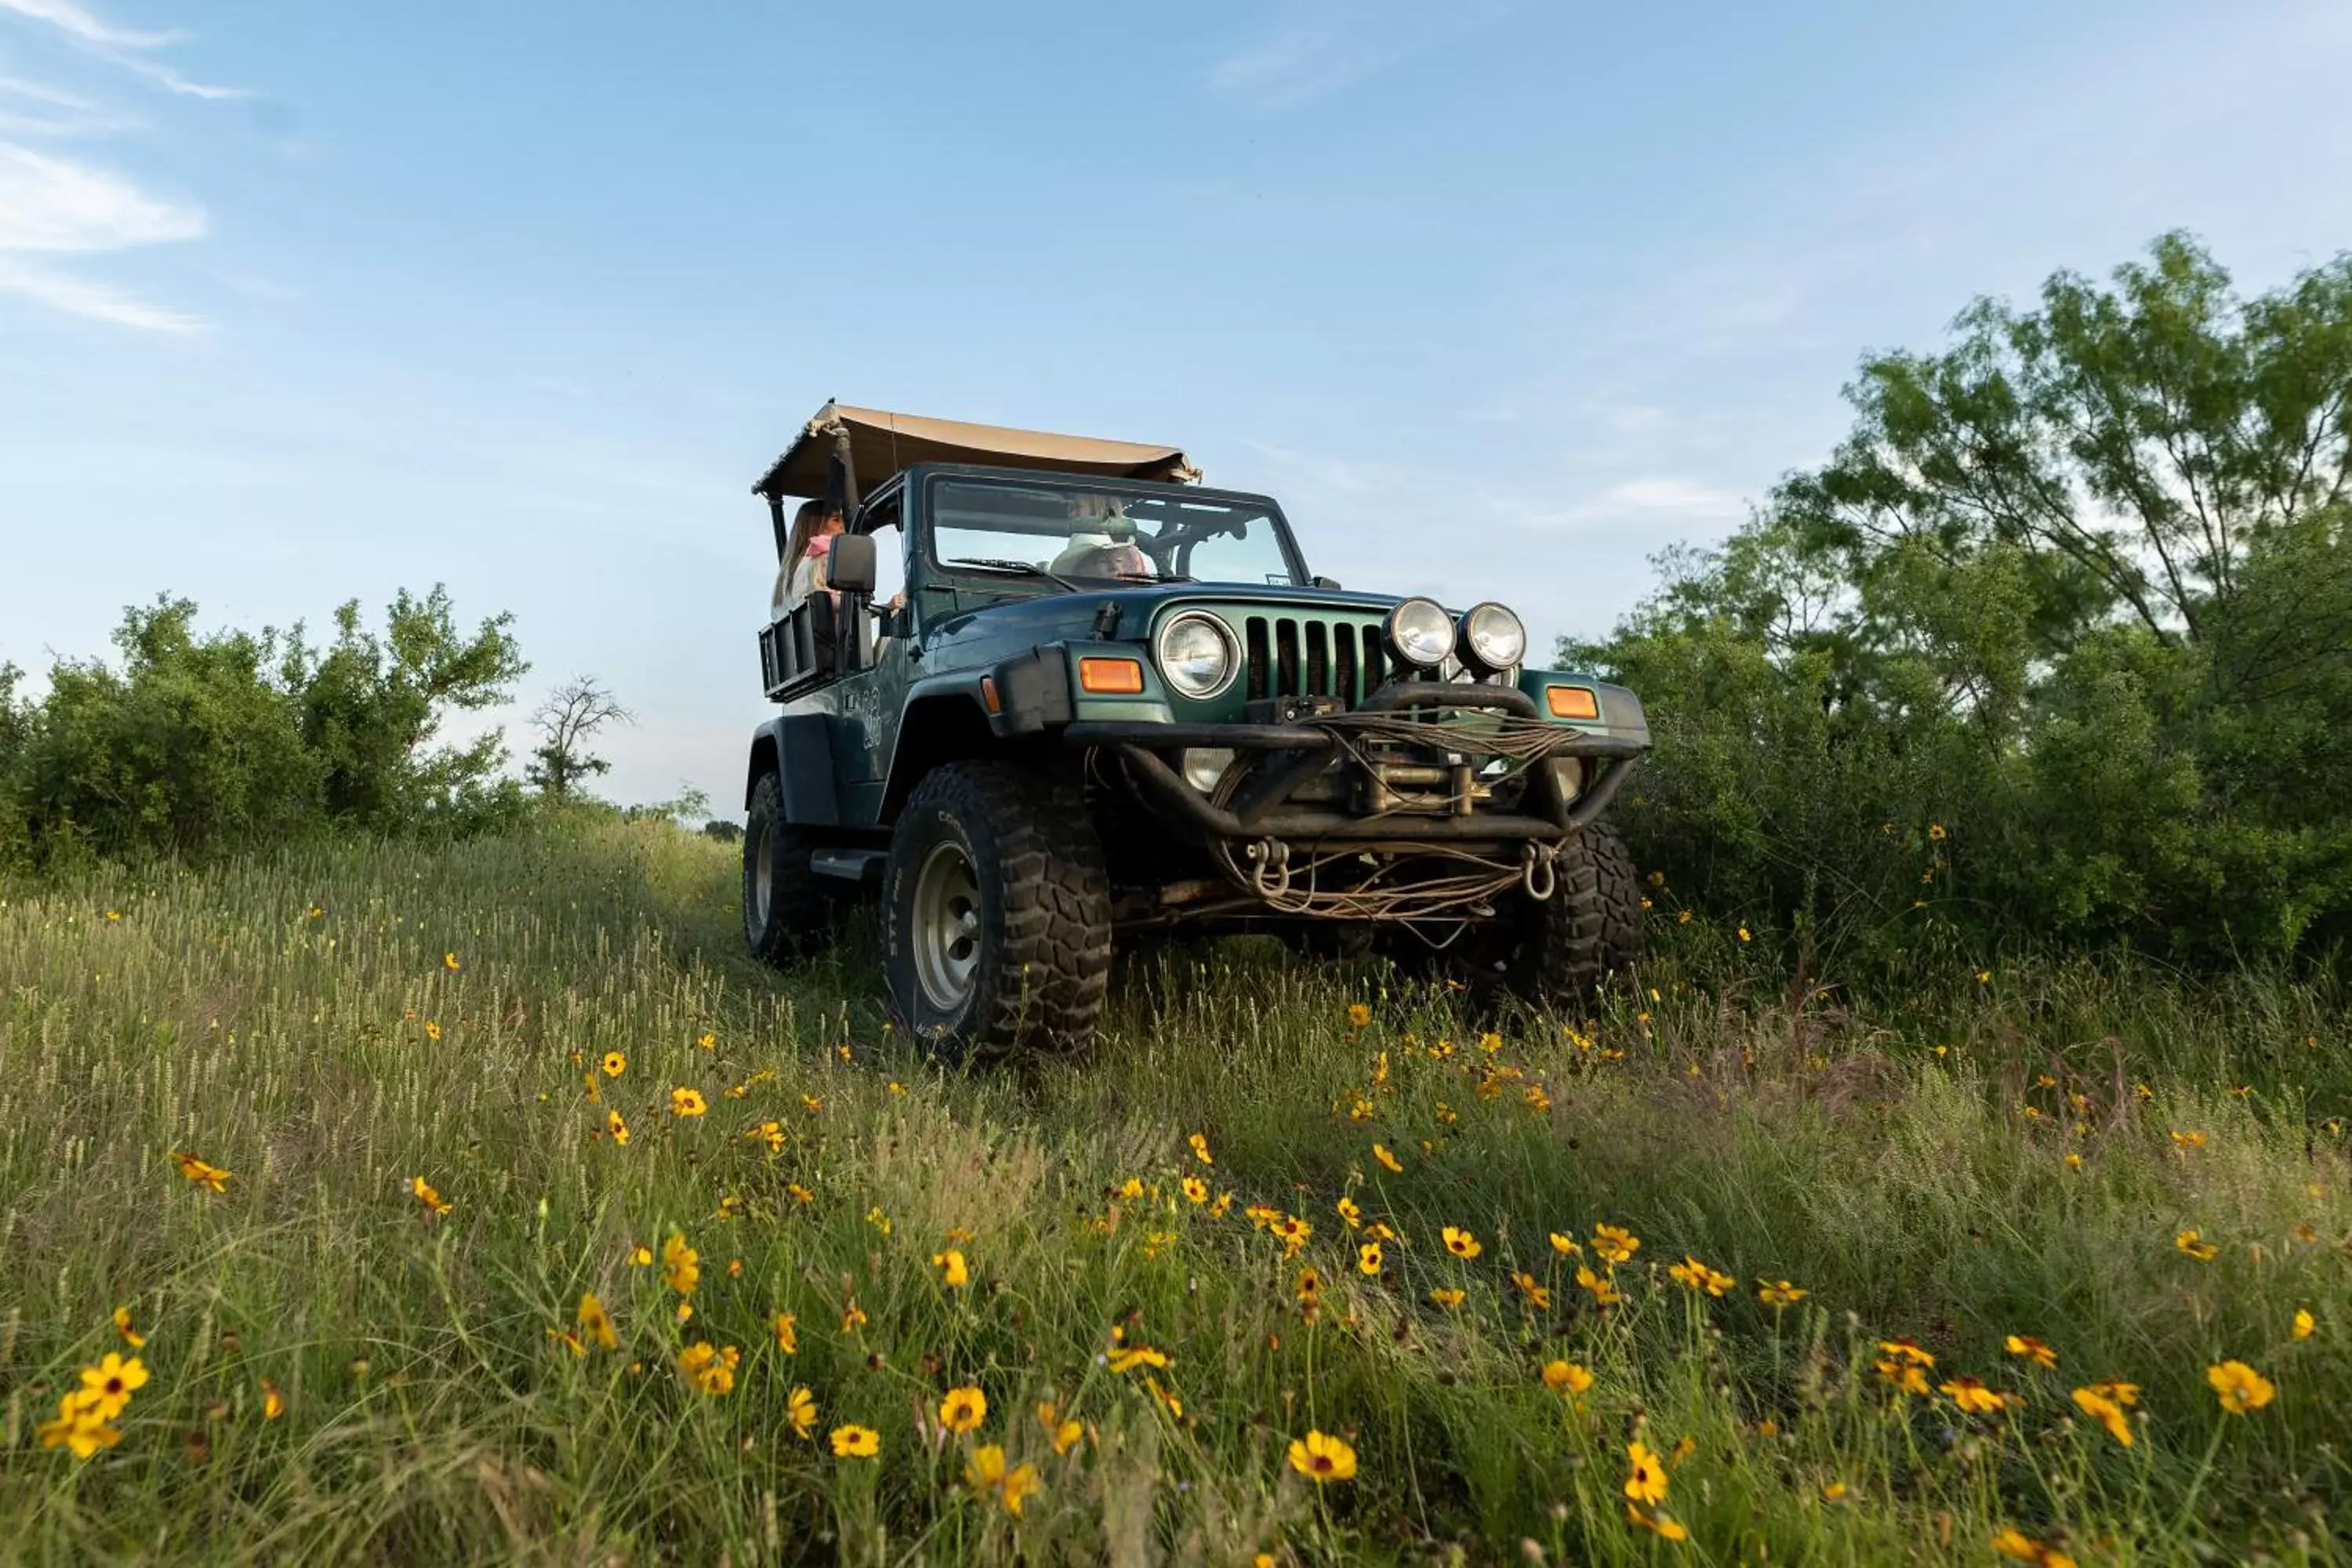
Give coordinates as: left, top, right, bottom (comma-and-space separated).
753, 402, 1200, 496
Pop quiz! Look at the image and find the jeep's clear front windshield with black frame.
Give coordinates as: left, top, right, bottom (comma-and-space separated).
931, 480, 1301, 588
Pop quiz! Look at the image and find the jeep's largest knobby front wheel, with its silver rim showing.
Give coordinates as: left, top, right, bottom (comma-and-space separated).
882, 762, 1110, 1065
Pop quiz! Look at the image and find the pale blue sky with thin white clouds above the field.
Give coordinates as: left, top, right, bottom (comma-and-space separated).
0, 0, 2352, 806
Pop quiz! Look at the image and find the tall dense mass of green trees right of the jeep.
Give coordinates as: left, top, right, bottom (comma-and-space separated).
1581, 235, 2352, 952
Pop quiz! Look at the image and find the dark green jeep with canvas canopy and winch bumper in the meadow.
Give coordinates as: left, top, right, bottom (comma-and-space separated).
743, 405, 1649, 1060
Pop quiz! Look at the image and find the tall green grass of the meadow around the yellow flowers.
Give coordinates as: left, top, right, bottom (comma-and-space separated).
0, 825, 2352, 1563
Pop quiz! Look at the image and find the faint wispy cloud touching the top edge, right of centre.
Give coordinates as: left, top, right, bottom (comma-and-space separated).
1209, 0, 1519, 108
